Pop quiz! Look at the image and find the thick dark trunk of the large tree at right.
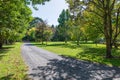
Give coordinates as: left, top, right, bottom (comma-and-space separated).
103, 3, 113, 58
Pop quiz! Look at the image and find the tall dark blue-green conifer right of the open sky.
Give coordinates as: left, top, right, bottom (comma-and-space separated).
54, 10, 70, 42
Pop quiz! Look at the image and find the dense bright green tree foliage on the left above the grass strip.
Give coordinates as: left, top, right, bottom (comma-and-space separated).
0, 0, 31, 47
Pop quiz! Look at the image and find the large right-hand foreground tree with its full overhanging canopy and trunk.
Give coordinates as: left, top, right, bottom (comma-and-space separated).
66, 0, 120, 58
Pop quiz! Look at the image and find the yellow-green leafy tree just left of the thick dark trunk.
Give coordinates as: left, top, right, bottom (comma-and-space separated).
83, 11, 104, 43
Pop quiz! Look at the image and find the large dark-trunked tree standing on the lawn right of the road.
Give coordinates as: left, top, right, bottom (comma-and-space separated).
66, 0, 120, 58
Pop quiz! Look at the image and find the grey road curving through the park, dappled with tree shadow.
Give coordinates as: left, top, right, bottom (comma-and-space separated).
21, 43, 120, 80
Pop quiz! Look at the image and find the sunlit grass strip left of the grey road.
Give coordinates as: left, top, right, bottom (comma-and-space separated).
0, 43, 27, 80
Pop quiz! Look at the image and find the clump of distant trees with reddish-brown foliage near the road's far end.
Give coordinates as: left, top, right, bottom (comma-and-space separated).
24, 17, 53, 43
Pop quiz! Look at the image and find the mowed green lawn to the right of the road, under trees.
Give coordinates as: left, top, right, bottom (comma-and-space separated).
33, 42, 120, 67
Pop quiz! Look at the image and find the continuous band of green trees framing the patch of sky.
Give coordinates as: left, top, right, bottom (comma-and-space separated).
0, 0, 120, 58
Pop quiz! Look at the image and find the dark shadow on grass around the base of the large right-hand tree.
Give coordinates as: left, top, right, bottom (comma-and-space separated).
76, 47, 120, 66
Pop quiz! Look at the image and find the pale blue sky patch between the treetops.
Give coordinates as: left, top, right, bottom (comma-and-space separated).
30, 0, 68, 25
